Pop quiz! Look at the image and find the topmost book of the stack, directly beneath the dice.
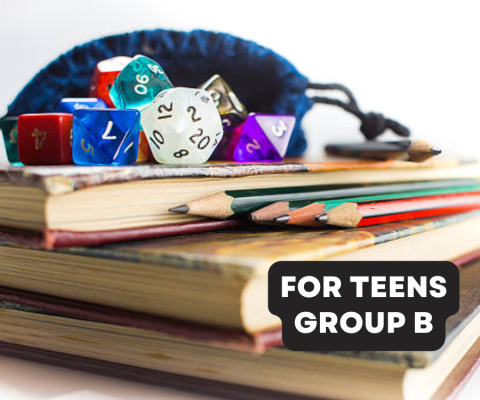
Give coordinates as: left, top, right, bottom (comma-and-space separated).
0, 158, 480, 236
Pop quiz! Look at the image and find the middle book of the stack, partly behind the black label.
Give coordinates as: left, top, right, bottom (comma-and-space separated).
0, 212, 480, 333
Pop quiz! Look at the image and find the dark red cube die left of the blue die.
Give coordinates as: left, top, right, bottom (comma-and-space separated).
18, 113, 73, 165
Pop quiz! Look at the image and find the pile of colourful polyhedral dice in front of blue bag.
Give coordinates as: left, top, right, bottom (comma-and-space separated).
0, 55, 295, 165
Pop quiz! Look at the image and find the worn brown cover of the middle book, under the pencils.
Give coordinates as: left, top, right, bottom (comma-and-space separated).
60, 211, 480, 278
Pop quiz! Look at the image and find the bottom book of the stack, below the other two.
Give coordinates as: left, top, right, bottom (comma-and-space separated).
0, 256, 480, 400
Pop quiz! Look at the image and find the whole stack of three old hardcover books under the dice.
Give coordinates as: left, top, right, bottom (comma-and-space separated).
0, 158, 480, 400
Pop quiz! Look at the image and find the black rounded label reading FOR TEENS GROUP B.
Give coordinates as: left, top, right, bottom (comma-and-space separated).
268, 261, 460, 351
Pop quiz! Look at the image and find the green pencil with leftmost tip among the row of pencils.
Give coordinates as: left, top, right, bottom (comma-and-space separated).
169, 179, 480, 219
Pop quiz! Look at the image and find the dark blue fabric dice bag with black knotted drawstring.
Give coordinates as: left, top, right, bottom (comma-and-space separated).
1, 29, 409, 164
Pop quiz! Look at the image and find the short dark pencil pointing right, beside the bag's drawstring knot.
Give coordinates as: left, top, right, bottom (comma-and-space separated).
325, 140, 442, 162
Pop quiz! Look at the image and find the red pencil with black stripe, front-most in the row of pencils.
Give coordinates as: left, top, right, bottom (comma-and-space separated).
317, 192, 480, 228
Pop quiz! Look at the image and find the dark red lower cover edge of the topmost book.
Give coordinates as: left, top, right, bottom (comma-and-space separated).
0, 219, 251, 250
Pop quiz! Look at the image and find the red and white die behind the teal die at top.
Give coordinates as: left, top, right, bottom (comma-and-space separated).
90, 56, 132, 108
